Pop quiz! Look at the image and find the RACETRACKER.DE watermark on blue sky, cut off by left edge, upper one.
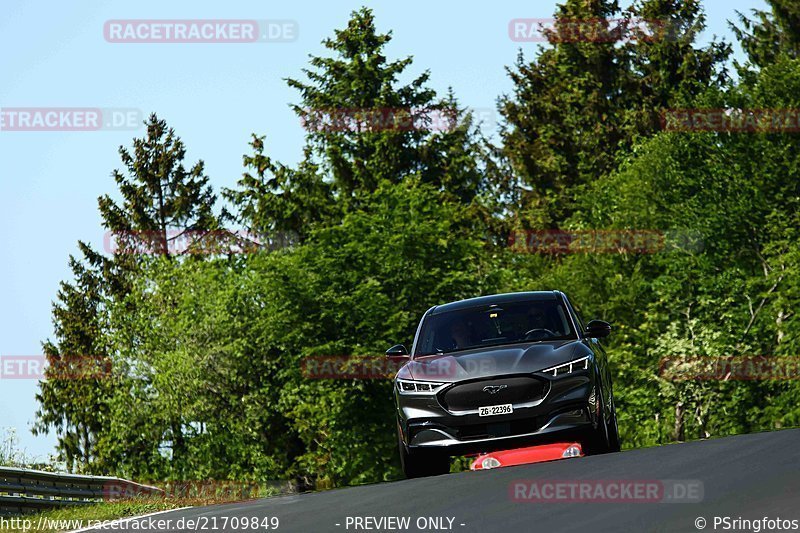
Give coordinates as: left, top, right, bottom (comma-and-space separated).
0, 107, 143, 132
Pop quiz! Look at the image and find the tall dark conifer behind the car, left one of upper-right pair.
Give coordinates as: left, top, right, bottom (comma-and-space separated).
500, 0, 624, 223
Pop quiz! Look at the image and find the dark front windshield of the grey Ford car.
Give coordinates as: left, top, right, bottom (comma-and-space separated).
415, 300, 576, 356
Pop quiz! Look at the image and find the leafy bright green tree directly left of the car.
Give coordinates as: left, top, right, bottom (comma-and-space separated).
270, 180, 496, 487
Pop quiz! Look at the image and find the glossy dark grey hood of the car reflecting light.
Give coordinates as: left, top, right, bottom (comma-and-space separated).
404, 340, 592, 383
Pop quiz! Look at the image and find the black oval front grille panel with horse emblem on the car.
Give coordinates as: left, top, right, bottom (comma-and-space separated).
439, 376, 549, 411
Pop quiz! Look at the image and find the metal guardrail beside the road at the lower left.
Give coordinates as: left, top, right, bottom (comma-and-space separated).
0, 467, 164, 515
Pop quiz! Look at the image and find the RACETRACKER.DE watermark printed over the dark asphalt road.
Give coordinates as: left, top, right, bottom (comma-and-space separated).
508, 479, 704, 503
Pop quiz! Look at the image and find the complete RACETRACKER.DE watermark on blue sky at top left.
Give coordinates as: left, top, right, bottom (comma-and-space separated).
103, 19, 299, 44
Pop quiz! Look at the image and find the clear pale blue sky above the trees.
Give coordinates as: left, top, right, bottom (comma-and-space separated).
0, 0, 764, 458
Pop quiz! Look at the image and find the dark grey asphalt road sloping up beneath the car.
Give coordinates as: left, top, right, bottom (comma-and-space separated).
84, 430, 800, 532
